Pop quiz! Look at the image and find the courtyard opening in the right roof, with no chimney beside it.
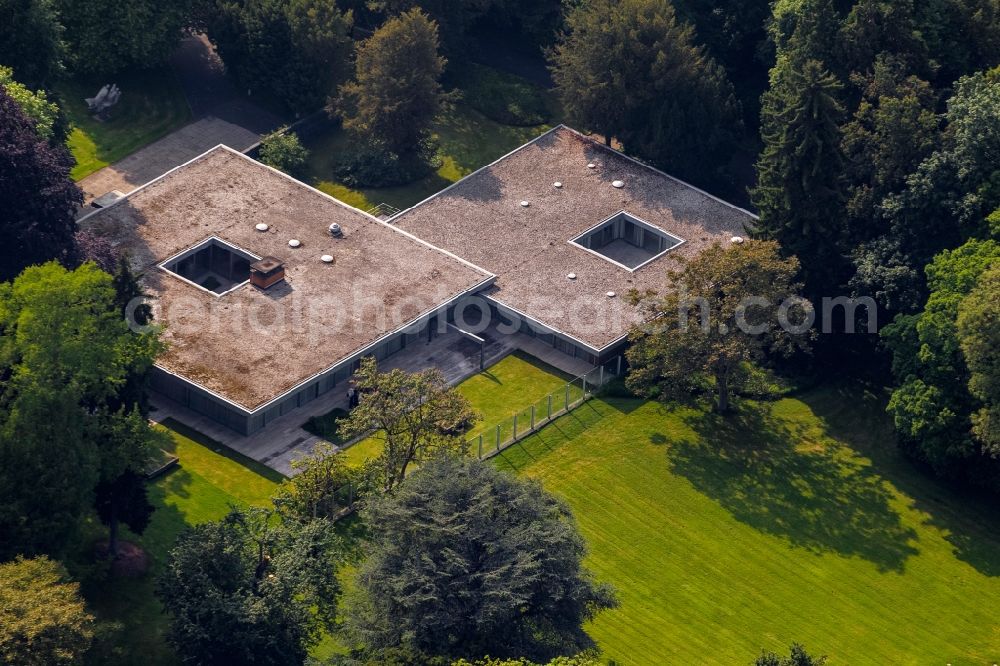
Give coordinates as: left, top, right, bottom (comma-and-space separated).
570, 211, 684, 271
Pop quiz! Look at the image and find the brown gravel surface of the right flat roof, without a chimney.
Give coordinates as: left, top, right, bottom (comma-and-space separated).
393, 126, 755, 349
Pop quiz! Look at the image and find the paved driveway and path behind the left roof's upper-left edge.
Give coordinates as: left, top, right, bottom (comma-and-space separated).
77, 35, 281, 204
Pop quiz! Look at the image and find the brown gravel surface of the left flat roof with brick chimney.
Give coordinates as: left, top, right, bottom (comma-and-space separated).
81, 146, 493, 410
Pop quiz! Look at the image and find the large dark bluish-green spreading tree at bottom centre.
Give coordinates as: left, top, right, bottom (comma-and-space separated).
346, 456, 614, 657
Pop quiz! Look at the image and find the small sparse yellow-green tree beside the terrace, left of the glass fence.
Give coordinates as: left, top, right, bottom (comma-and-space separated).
338, 357, 477, 492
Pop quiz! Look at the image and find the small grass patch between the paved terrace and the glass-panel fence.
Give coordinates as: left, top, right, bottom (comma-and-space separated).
343, 352, 579, 466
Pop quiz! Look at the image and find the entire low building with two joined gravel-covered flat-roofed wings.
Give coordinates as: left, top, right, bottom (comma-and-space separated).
81, 126, 754, 434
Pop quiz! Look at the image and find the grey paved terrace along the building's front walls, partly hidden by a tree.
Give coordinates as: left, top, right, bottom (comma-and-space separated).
151, 330, 593, 475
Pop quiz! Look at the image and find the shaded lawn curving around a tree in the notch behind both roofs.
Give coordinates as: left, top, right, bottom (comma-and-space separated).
304, 104, 549, 210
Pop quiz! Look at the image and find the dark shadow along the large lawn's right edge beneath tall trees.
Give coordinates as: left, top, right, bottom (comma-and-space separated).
800, 387, 1000, 576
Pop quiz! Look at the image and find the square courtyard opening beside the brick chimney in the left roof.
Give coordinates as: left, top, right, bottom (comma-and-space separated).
160, 236, 260, 296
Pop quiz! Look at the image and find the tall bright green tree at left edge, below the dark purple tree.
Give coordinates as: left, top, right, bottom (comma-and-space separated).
0, 263, 159, 557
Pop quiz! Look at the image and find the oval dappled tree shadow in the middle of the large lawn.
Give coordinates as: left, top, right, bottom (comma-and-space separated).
668, 402, 919, 572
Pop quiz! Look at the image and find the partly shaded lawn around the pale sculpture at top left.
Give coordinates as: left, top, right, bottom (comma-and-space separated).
58, 67, 191, 180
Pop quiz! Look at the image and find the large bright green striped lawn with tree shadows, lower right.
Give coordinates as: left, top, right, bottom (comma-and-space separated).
495, 388, 1000, 666
